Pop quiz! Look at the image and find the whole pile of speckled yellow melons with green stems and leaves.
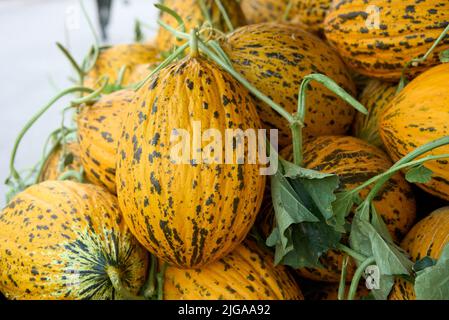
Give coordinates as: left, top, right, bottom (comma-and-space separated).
0, 0, 449, 300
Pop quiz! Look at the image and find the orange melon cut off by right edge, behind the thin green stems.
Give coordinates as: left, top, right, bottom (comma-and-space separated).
379, 63, 449, 201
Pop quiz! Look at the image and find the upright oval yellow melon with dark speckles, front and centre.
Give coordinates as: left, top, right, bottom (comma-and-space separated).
116, 56, 265, 268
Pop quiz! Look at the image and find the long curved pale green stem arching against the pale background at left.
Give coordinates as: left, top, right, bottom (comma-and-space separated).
9, 86, 93, 187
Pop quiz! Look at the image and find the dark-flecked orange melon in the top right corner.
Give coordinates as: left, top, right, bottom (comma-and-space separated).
324, 0, 449, 82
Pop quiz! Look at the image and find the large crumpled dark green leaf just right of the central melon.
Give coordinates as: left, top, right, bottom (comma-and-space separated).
266, 159, 341, 268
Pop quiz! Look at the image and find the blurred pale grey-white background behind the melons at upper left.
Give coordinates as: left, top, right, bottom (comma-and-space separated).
0, 0, 158, 207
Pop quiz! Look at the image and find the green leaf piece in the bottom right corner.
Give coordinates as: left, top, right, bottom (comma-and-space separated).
415, 244, 449, 300
